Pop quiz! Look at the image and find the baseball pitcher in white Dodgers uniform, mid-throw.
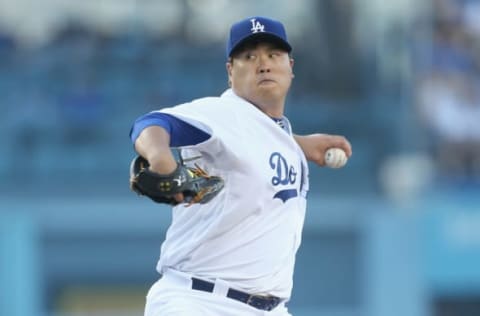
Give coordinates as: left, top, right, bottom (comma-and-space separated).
130, 16, 352, 316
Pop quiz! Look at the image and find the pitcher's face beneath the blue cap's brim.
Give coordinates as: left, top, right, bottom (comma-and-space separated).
227, 42, 293, 106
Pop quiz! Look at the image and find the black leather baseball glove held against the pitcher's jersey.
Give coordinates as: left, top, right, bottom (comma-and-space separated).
130, 156, 224, 205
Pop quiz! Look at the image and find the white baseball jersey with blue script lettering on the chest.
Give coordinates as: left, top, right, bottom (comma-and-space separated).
157, 89, 308, 299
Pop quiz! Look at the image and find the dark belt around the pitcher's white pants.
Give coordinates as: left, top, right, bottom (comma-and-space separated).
192, 278, 282, 311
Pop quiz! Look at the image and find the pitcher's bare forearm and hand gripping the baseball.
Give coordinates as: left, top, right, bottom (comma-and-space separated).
293, 134, 352, 166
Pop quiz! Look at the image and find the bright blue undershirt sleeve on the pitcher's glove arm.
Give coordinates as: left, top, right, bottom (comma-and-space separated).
130, 112, 210, 147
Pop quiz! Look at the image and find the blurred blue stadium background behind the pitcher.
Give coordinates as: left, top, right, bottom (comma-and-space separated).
0, 0, 480, 316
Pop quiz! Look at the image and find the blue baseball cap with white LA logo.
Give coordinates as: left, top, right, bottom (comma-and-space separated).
227, 16, 292, 58
